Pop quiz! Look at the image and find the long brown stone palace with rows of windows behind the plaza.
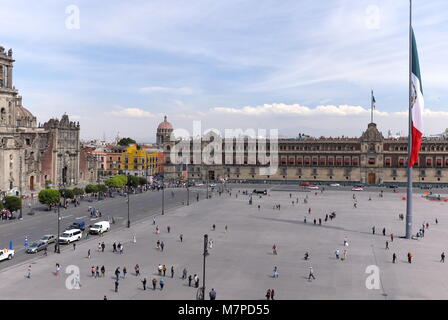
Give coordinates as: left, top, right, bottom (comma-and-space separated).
162, 120, 448, 184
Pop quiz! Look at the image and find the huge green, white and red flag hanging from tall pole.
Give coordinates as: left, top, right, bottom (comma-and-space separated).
409, 29, 425, 168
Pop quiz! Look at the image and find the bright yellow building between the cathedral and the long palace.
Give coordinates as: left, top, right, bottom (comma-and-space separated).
121, 144, 160, 176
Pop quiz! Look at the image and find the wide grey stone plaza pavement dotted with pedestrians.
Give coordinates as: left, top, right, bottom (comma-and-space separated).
0, 187, 448, 300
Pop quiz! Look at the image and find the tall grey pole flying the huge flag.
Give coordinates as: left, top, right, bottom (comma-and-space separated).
406, 0, 412, 239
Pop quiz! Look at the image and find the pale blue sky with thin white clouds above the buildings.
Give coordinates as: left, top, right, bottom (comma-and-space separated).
0, 0, 448, 142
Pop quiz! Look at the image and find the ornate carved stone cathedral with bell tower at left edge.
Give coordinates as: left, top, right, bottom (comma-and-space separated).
0, 47, 96, 194
